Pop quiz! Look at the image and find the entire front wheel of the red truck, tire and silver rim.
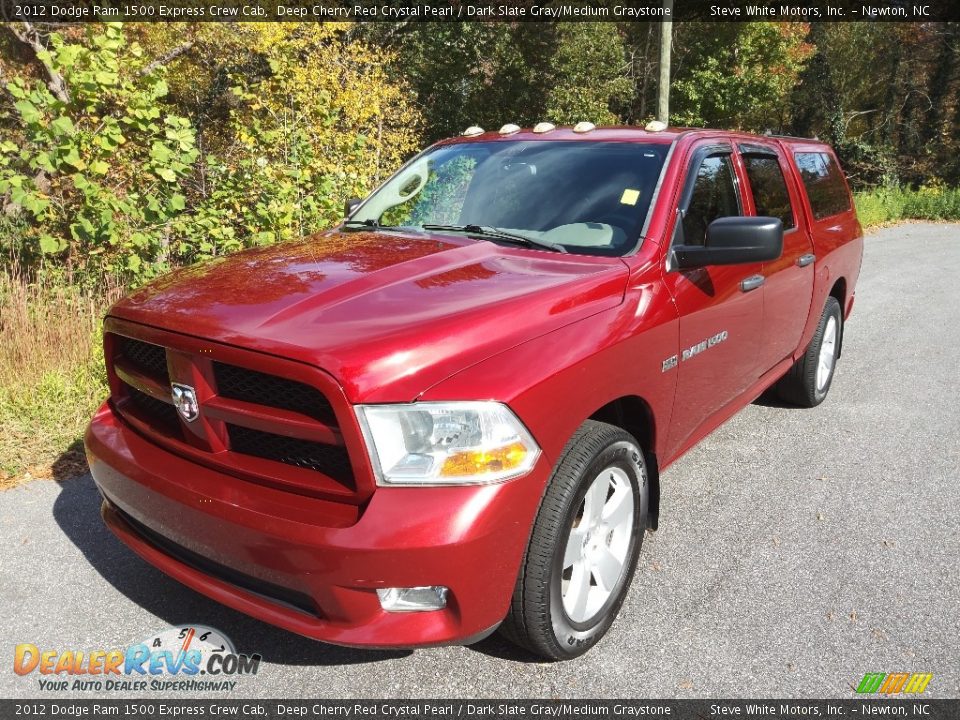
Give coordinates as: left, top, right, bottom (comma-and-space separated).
501, 420, 650, 660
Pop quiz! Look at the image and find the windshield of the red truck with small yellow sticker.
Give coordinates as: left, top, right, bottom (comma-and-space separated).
351, 140, 669, 255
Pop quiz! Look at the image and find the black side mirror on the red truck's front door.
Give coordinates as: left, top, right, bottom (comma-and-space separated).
673, 215, 783, 268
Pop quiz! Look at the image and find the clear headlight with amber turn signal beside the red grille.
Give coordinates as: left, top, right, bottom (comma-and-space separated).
357, 402, 540, 485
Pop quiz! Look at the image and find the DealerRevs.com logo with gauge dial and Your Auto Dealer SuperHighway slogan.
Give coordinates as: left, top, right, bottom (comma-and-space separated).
13, 625, 261, 692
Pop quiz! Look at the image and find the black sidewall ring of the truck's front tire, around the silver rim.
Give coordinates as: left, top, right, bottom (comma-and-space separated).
548, 439, 649, 657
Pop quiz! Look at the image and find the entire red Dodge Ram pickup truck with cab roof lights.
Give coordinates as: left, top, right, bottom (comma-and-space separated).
86, 123, 863, 659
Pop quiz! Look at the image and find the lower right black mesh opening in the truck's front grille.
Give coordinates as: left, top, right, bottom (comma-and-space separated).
227, 424, 353, 483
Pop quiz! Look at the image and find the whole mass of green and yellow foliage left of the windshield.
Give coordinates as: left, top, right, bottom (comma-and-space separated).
0, 24, 417, 283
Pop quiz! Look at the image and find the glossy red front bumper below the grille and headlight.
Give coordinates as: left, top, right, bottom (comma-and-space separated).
85, 403, 549, 647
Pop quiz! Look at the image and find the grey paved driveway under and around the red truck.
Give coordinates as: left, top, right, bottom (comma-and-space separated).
0, 224, 960, 698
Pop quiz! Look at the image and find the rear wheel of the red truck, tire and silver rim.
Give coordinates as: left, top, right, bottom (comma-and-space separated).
777, 296, 843, 408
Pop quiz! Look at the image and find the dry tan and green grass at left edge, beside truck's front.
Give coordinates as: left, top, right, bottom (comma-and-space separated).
0, 270, 115, 488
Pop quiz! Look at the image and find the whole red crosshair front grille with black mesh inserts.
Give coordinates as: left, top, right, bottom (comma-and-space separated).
108, 329, 360, 497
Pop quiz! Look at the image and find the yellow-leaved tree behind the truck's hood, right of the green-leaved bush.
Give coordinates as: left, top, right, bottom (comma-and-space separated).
167, 23, 419, 259
